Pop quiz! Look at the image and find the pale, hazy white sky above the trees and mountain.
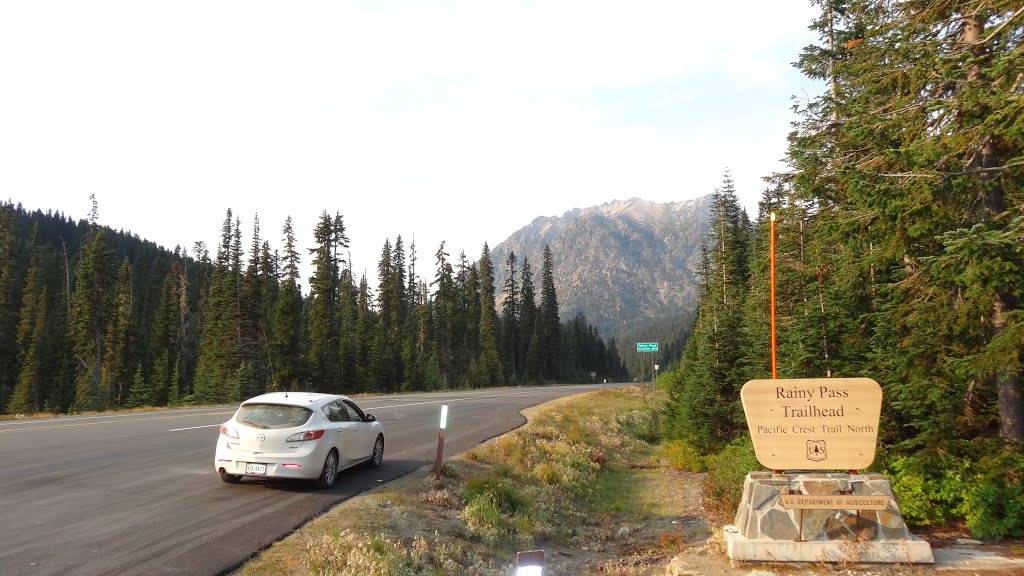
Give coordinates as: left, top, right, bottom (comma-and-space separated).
0, 0, 818, 286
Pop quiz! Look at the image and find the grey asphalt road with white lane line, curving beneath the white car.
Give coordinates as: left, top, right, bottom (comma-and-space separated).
0, 385, 600, 576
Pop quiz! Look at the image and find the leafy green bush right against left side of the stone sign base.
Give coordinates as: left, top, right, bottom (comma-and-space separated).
703, 436, 764, 522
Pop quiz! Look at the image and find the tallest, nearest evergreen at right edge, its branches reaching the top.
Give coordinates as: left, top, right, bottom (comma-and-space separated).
790, 0, 1024, 438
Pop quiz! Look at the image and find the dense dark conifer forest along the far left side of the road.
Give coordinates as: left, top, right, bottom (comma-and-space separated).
0, 198, 626, 414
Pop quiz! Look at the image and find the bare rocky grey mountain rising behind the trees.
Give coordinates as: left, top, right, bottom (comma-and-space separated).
490, 195, 712, 339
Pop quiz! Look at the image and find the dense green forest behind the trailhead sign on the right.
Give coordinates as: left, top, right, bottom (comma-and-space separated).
664, 0, 1024, 536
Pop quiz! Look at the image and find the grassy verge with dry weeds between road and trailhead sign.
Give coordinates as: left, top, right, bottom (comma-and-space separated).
228, 387, 720, 576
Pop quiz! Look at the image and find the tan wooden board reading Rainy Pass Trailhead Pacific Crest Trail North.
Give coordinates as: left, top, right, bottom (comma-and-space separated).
739, 378, 882, 470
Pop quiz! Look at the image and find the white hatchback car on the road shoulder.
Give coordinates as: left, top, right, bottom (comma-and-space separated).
213, 393, 384, 488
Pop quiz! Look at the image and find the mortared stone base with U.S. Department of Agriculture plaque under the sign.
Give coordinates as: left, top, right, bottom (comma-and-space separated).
724, 471, 935, 564
